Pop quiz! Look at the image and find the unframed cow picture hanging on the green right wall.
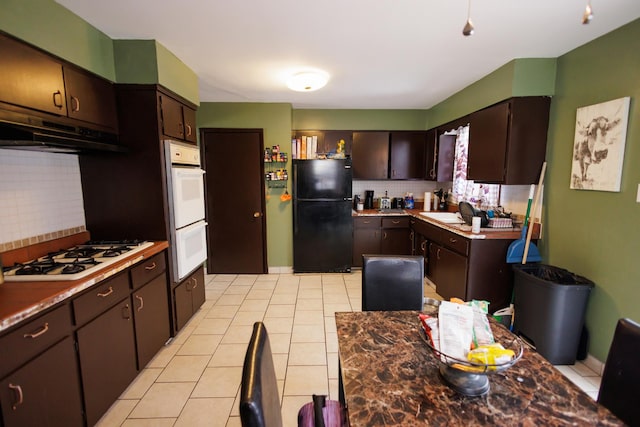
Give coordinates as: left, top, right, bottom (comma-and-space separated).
570, 97, 631, 191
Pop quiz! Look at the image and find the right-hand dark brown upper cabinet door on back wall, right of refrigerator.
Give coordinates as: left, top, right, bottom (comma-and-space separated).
389, 132, 427, 179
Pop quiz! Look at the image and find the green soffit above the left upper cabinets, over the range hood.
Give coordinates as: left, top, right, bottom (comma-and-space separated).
0, 0, 116, 81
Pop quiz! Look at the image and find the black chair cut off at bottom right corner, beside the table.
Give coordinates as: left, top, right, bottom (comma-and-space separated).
598, 319, 640, 426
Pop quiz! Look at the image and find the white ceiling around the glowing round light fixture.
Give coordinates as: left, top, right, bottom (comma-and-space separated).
57, 0, 640, 109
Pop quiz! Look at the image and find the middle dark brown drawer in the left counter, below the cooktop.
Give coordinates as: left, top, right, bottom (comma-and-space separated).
73, 272, 129, 325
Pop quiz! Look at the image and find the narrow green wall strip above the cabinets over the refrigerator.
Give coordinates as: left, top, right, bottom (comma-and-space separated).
292, 110, 427, 130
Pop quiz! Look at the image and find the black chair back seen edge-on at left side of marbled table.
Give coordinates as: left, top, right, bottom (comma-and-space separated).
240, 322, 282, 427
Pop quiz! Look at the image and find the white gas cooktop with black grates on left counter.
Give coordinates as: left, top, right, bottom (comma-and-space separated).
3, 240, 153, 282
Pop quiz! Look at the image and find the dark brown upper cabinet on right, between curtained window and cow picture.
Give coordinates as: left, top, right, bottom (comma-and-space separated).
467, 97, 550, 185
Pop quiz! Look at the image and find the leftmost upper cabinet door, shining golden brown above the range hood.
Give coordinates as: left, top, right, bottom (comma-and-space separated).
0, 35, 67, 116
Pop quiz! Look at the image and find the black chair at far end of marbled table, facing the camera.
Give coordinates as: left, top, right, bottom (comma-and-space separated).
362, 255, 424, 311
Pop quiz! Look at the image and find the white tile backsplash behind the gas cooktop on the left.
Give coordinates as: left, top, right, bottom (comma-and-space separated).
0, 149, 86, 252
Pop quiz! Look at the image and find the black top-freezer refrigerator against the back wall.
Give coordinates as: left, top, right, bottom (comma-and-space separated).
293, 159, 353, 273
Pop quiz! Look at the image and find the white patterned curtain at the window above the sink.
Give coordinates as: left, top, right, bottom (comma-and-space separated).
451, 125, 500, 209
